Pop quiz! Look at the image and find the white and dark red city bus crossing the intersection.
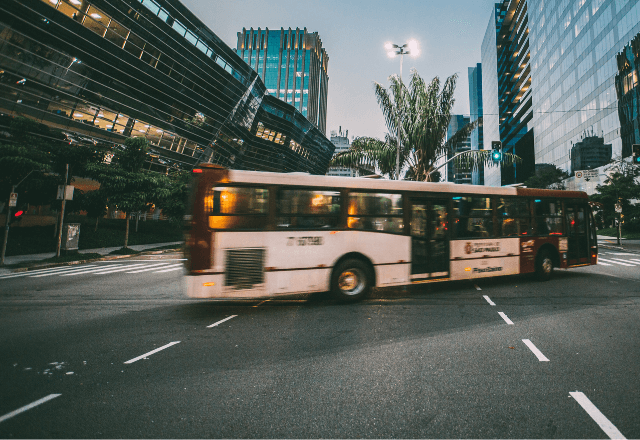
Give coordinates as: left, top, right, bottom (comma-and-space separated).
185, 164, 598, 302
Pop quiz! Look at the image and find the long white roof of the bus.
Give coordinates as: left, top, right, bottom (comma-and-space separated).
201, 164, 587, 199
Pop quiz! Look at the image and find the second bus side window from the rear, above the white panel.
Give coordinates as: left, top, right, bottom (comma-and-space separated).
276, 189, 340, 229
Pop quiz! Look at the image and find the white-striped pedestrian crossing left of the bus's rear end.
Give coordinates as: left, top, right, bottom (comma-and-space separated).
0, 260, 184, 280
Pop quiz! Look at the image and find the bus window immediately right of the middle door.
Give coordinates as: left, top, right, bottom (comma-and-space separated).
453, 197, 493, 238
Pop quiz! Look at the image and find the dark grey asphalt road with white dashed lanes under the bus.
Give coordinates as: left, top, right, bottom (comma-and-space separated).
0, 250, 640, 438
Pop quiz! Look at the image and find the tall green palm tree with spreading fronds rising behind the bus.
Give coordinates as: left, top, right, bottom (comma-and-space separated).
331, 69, 520, 181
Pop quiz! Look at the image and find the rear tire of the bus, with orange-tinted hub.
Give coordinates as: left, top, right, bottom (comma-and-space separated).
331, 258, 373, 302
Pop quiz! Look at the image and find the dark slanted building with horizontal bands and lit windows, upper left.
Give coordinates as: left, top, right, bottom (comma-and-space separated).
0, 0, 334, 174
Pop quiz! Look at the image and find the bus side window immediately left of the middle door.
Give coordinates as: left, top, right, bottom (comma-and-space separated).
347, 192, 404, 233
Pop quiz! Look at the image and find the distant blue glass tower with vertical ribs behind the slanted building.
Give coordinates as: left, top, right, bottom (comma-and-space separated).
236, 28, 329, 133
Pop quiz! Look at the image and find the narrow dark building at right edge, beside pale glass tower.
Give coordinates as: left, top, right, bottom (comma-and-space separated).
615, 30, 640, 151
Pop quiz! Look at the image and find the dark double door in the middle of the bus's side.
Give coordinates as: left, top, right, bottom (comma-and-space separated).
411, 199, 449, 280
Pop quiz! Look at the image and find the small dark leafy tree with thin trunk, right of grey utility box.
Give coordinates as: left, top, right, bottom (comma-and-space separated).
88, 137, 169, 249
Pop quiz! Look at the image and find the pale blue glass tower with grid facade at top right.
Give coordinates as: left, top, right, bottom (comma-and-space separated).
528, 0, 640, 171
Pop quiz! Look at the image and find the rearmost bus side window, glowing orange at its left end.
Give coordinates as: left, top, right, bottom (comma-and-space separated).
204, 186, 269, 229
